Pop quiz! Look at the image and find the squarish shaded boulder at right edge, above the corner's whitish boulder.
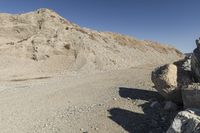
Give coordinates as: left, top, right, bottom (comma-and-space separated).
182, 83, 200, 109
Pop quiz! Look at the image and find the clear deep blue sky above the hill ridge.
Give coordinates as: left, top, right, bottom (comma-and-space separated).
0, 0, 200, 52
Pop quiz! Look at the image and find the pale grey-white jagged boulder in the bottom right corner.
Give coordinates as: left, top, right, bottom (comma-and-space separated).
167, 109, 200, 133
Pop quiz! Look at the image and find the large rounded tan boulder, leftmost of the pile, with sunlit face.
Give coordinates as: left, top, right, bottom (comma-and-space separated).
151, 64, 182, 102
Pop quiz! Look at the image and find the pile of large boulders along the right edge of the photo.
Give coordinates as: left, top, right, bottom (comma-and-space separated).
151, 39, 200, 133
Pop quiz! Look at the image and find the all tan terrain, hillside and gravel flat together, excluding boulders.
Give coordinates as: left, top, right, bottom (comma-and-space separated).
0, 9, 184, 133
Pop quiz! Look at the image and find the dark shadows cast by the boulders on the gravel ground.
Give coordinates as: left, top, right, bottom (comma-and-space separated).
109, 87, 177, 133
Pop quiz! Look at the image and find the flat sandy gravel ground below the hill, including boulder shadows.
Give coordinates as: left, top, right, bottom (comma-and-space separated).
0, 66, 178, 133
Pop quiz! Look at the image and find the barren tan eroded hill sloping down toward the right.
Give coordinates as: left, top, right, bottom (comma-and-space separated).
0, 9, 182, 78
